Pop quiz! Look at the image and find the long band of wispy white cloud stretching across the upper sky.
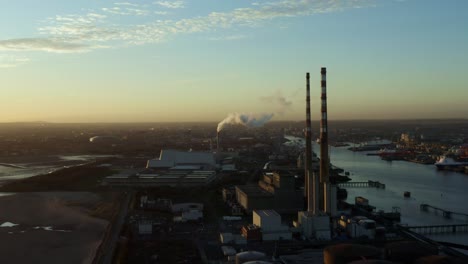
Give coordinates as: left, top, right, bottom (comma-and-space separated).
0, 0, 376, 53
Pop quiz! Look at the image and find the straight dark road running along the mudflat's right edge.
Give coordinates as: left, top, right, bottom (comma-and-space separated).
93, 191, 135, 264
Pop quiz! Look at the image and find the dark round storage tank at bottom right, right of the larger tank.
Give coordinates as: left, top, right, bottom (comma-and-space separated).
385, 241, 438, 264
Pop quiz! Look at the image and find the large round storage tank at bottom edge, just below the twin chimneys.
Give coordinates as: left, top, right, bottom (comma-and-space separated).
323, 244, 382, 264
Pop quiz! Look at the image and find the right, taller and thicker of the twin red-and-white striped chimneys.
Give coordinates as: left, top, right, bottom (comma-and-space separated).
320, 67, 331, 212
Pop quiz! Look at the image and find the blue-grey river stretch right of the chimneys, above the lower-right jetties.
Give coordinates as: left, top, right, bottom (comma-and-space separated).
330, 144, 468, 220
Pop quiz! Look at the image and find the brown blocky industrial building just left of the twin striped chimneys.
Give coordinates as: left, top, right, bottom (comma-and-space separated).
236, 172, 303, 213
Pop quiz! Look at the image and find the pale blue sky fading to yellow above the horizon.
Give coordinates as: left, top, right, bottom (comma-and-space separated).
0, 0, 468, 122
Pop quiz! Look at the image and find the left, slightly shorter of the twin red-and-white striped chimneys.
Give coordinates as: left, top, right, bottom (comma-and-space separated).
304, 73, 318, 214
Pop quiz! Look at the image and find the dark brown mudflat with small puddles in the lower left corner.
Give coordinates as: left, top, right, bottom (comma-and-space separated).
0, 192, 109, 264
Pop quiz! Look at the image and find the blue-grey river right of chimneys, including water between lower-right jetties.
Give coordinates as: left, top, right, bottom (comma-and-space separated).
326, 145, 468, 245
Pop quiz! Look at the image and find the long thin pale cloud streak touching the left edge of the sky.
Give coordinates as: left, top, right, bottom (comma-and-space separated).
0, 38, 93, 53
